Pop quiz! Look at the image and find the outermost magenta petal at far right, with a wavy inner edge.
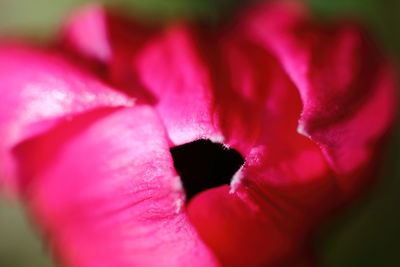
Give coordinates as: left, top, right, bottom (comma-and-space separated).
246, 3, 395, 184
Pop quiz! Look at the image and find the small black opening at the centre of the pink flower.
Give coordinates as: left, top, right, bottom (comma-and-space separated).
170, 139, 244, 201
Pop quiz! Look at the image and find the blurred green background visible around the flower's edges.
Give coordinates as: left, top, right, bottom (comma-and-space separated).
0, 0, 400, 267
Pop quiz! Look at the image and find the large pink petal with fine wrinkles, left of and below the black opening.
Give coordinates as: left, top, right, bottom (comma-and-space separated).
16, 107, 217, 267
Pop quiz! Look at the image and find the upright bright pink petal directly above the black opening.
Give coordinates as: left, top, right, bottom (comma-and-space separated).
134, 25, 222, 145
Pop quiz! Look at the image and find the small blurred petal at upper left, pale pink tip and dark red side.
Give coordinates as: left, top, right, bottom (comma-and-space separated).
61, 5, 156, 103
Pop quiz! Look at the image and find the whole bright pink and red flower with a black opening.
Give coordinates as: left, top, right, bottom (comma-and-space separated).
0, 2, 395, 267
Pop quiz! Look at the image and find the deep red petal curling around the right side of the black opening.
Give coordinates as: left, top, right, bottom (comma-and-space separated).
188, 34, 342, 266
